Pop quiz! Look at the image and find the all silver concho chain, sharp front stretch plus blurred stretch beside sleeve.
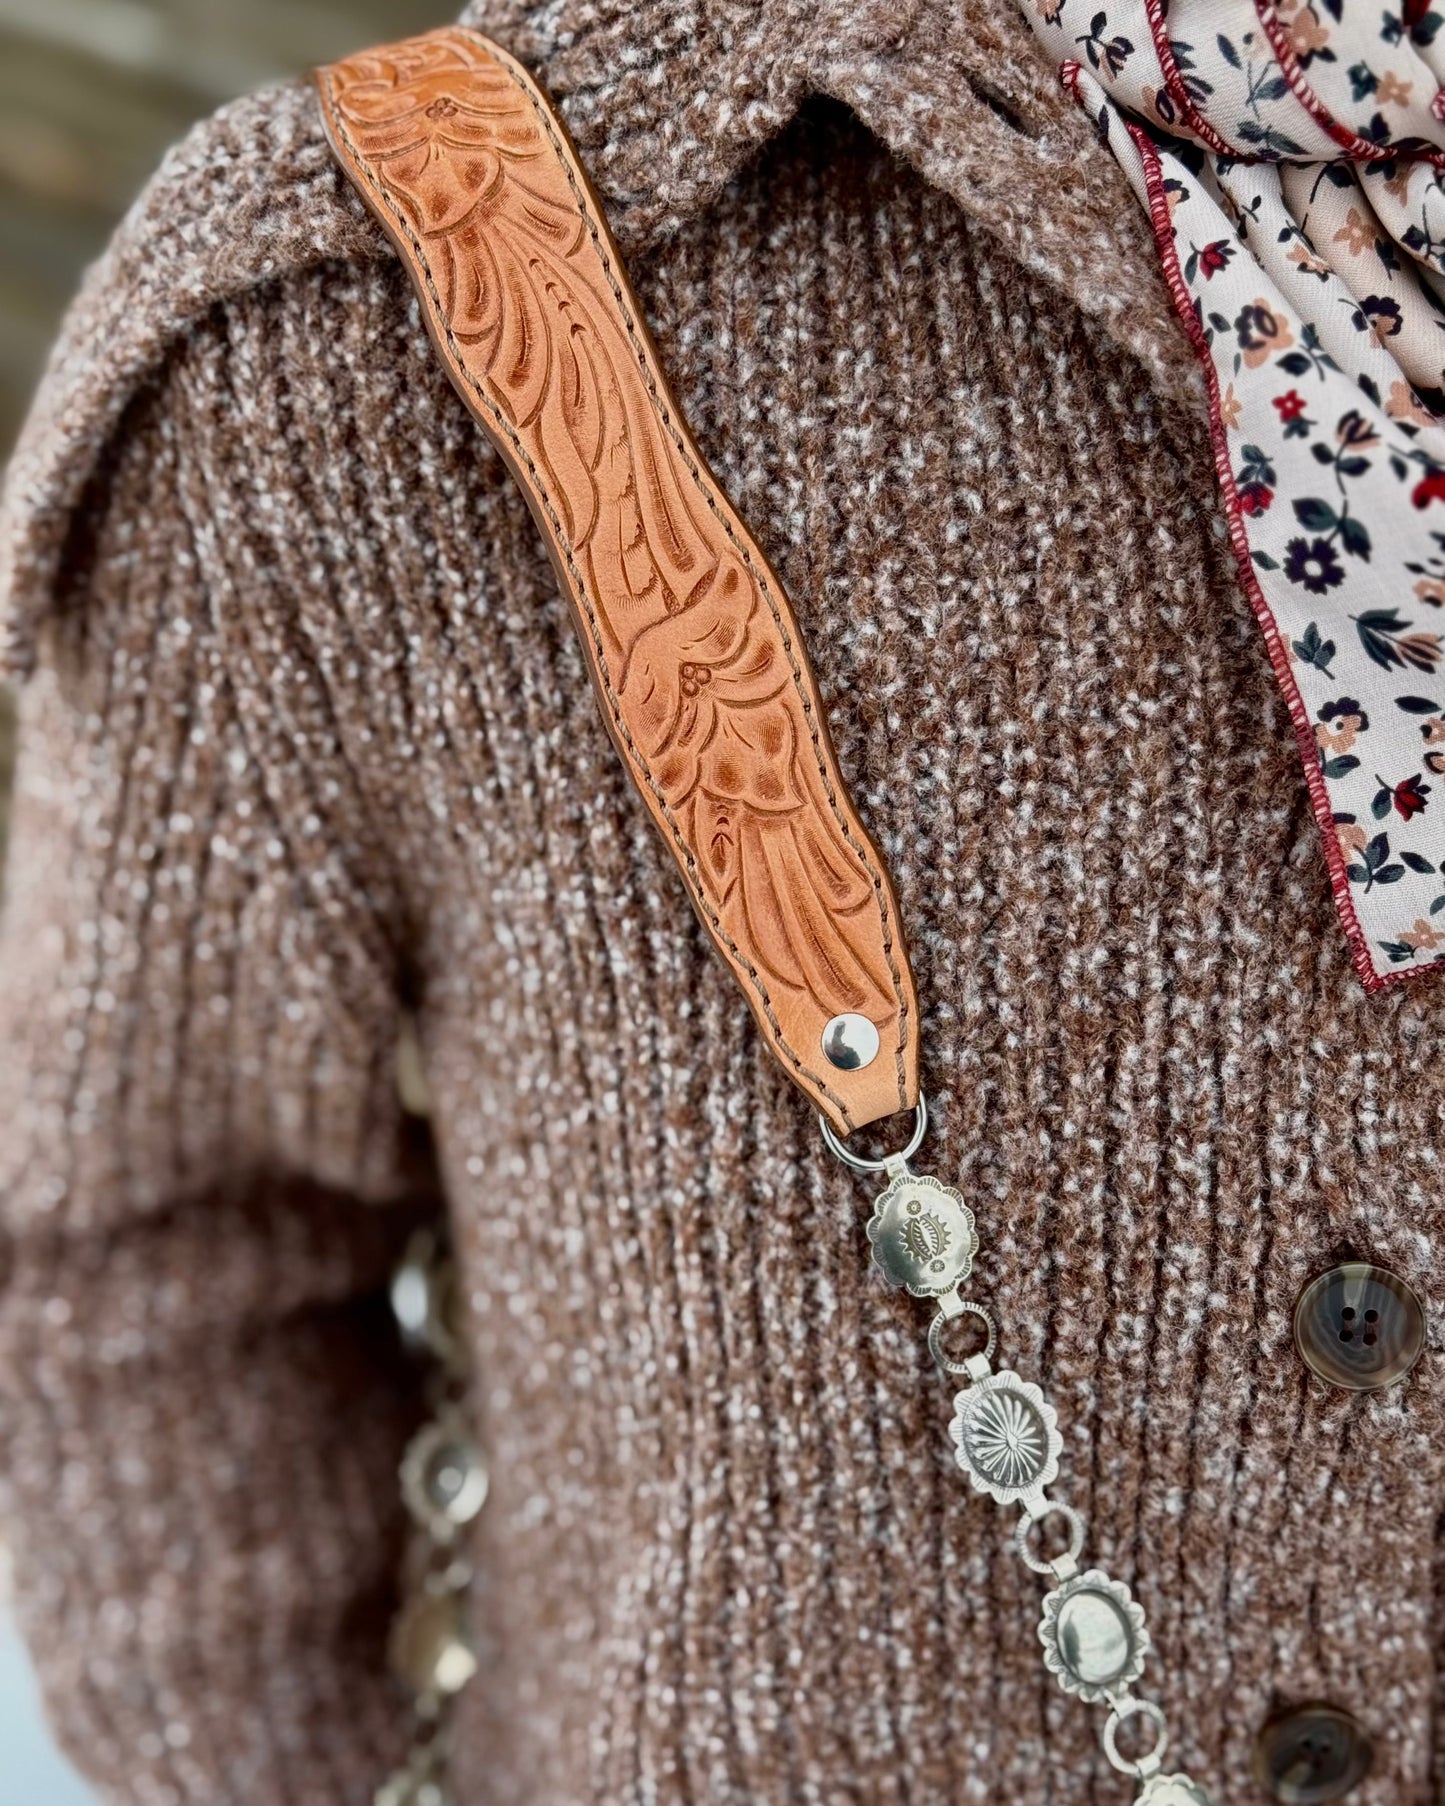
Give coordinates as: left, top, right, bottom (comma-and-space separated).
374, 1134, 1210, 1806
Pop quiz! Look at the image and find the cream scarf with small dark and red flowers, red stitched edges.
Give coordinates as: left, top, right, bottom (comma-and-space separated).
1026, 0, 1445, 990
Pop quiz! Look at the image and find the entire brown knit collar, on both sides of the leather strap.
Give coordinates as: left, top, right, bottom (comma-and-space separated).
0, 0, 1203, 689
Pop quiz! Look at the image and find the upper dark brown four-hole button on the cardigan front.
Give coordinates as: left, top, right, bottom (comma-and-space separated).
1295, 1261, 1425, 1392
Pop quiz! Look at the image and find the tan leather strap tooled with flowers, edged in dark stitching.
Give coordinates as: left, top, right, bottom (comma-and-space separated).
318, 25, 918, 1131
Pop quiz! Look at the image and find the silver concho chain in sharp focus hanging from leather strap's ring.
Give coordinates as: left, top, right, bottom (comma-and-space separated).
820, 1100, 1210, 1806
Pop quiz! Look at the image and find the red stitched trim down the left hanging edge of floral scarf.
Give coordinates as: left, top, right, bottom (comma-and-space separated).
1119, 116, 1440, 993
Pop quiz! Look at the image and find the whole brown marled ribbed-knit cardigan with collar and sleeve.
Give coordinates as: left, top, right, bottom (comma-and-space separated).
0, 0, 1445, 1806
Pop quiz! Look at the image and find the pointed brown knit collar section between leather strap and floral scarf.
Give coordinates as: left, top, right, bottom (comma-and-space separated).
462, 0, 1198, 399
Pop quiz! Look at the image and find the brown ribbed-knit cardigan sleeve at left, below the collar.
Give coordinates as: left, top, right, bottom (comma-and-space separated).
0, 317, 435, 1806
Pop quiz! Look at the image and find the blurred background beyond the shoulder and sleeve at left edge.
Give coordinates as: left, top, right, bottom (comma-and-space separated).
0, 0, 451, 1806
